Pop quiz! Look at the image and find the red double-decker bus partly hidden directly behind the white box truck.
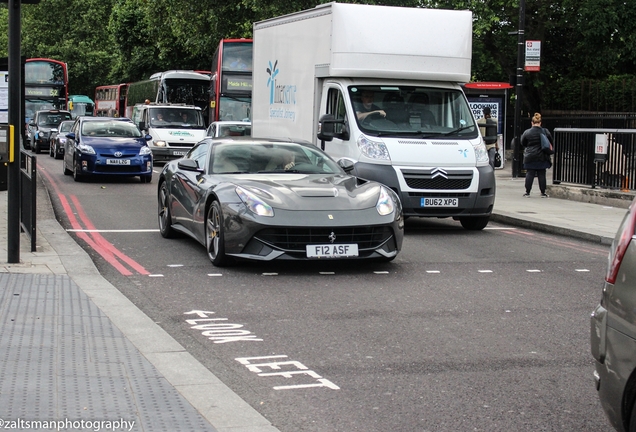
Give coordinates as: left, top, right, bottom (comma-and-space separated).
208, 39, 252, 123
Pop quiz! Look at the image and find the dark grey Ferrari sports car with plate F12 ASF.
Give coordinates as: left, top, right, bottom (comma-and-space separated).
158, 137, 404, 266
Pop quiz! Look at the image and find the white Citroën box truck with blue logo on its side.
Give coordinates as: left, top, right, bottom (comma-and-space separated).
252, 3, 495, 230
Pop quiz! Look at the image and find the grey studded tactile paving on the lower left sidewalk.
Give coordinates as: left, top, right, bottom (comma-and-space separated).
0, 273, 216, 432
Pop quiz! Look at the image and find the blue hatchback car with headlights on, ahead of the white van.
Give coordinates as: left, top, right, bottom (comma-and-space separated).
63, 117, 152, 183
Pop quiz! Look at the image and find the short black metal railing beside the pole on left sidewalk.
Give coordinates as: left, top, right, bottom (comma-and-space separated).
20, 149, 37, 252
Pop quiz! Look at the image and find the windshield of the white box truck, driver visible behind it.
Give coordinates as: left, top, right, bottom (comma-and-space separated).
349, 86, 479, 138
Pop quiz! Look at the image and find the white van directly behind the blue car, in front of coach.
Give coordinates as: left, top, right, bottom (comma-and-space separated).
132, 103, 206, 162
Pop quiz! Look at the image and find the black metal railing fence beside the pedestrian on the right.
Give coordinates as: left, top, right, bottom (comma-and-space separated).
552, 128, 636, 191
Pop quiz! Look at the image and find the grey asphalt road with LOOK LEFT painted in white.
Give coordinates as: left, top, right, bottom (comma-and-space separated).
38, 155, 610, 432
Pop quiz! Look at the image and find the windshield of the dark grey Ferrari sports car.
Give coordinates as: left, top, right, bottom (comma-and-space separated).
210, 142, 344, 175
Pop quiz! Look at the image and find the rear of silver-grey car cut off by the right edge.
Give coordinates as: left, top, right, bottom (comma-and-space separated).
591, 199, 636, 431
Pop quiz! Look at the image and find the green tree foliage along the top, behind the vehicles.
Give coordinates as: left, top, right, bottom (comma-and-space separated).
0, 0, 636, 112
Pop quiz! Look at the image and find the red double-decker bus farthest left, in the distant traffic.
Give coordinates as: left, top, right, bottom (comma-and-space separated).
24, 58, 68, 123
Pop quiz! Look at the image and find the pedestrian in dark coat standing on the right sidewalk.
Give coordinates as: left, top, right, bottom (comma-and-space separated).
521, 113, 554, 198
